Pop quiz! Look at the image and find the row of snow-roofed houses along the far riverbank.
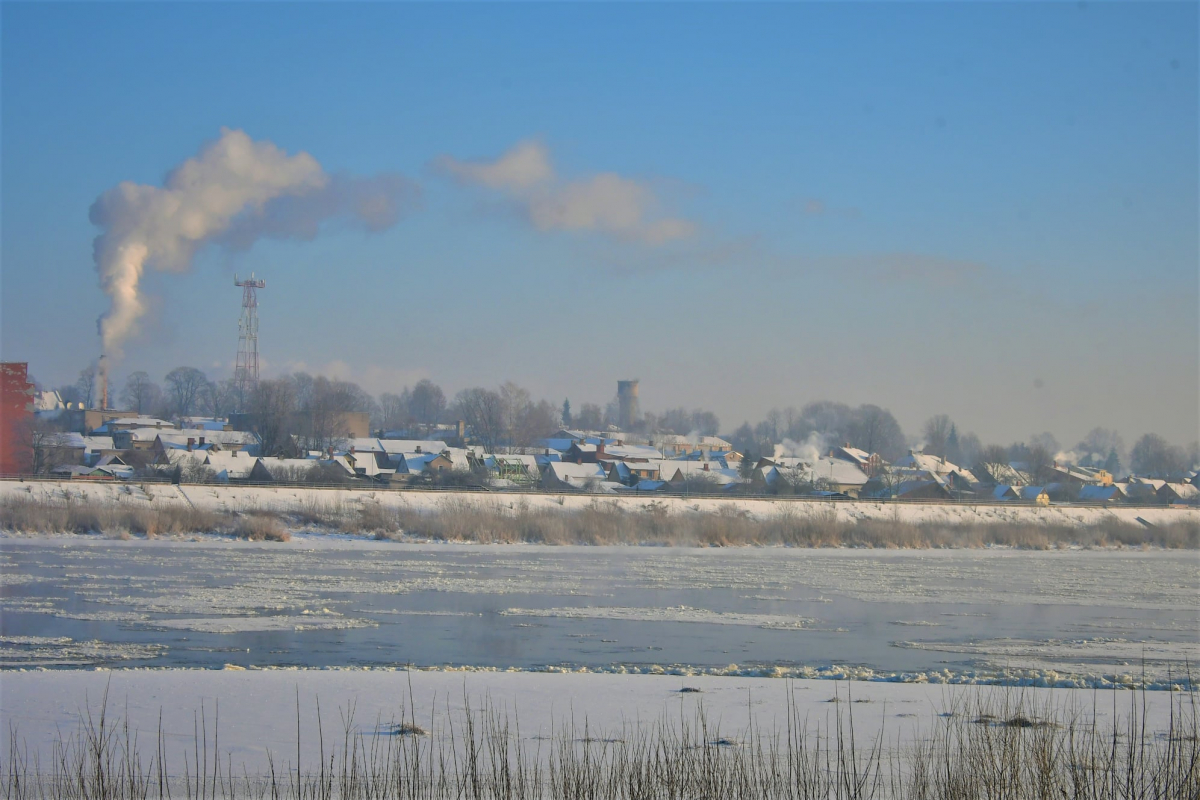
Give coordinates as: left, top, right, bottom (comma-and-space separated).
30, 417, 1200, 504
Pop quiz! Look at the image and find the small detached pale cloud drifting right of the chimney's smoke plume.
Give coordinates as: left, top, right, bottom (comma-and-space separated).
434, 140, 696, 245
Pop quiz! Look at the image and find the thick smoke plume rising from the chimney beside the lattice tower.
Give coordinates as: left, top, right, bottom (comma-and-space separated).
89, 128, 418, 355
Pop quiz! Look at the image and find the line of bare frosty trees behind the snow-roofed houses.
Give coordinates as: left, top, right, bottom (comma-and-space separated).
35, 365, 1200, 479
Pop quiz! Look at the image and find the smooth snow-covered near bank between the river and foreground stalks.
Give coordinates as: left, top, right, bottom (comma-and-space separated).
0, 669, 1178, 775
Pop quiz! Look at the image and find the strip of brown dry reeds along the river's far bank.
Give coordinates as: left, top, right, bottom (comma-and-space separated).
0, 495, 1200, 551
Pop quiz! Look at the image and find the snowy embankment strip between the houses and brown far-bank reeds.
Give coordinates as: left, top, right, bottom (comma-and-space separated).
0, 480, 1200, 525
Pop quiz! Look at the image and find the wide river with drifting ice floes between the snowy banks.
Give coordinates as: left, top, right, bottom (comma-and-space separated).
0, 536, 1200, 685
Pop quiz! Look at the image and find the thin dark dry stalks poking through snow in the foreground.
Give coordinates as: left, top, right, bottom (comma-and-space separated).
0, 688, 1200, 800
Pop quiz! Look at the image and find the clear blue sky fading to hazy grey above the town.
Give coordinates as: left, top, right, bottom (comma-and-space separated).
0, 2, 1200, 444
